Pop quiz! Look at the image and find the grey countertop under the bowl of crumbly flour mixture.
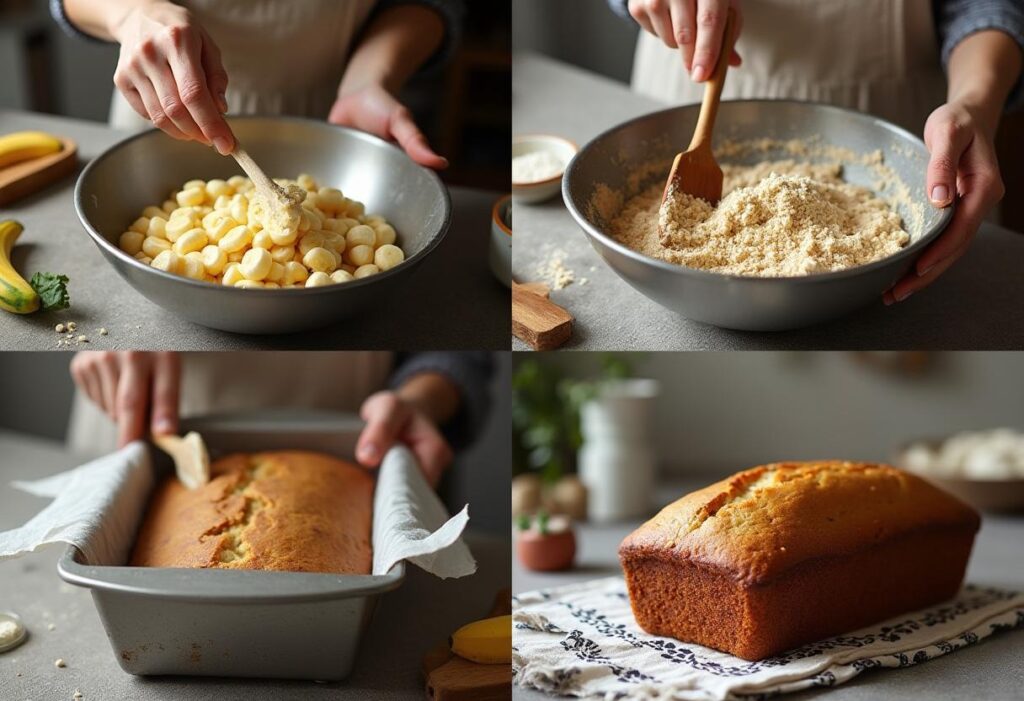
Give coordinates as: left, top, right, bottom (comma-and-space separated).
512, 54, 1024, 351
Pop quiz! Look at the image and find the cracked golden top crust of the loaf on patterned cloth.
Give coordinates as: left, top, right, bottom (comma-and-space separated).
620, 461, 980, 583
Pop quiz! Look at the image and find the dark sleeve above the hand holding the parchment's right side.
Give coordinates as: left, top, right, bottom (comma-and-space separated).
388, 351, 495, 448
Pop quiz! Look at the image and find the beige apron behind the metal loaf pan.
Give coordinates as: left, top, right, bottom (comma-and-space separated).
68, 351, 393, 455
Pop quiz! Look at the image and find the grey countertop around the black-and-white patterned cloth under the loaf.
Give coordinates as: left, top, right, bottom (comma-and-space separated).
512, 477, 1024, 701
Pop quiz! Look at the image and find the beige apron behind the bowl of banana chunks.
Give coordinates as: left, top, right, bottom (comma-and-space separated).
111, 0, 376, 130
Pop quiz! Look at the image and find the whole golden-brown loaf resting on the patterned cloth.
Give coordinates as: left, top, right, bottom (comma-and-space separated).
618, 462, 980, 660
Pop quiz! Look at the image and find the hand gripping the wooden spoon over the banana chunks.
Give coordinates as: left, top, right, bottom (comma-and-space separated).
111, 2, 234, 156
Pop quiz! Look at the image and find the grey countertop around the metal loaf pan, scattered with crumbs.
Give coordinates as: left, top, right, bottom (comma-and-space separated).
0, 431, 510, 701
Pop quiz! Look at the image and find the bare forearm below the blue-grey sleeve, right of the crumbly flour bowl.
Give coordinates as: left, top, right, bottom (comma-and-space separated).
946, 30, 1022, 135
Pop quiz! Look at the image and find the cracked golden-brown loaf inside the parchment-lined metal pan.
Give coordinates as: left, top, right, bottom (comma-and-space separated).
129, 451, 374, 574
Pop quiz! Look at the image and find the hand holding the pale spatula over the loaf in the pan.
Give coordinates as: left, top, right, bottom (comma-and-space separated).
71, 351, 181, 447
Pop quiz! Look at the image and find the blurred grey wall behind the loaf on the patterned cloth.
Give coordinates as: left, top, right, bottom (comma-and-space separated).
515, 352, 1024, 479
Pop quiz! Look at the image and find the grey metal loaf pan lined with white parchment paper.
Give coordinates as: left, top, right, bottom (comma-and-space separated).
57, 411, 406, 681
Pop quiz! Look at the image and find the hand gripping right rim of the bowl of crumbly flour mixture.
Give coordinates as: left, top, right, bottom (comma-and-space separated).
883, 102, 1006, 305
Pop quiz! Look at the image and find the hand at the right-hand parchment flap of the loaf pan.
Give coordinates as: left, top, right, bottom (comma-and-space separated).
355, 391, 452, 487
